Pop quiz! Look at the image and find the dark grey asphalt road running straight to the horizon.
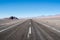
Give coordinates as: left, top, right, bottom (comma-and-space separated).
0, 19, 60, 40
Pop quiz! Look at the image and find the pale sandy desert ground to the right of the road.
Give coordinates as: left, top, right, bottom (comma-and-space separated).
34, 16, 60, 30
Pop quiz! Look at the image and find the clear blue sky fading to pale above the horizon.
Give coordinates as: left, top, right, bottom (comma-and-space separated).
0, 0, 60, 18
